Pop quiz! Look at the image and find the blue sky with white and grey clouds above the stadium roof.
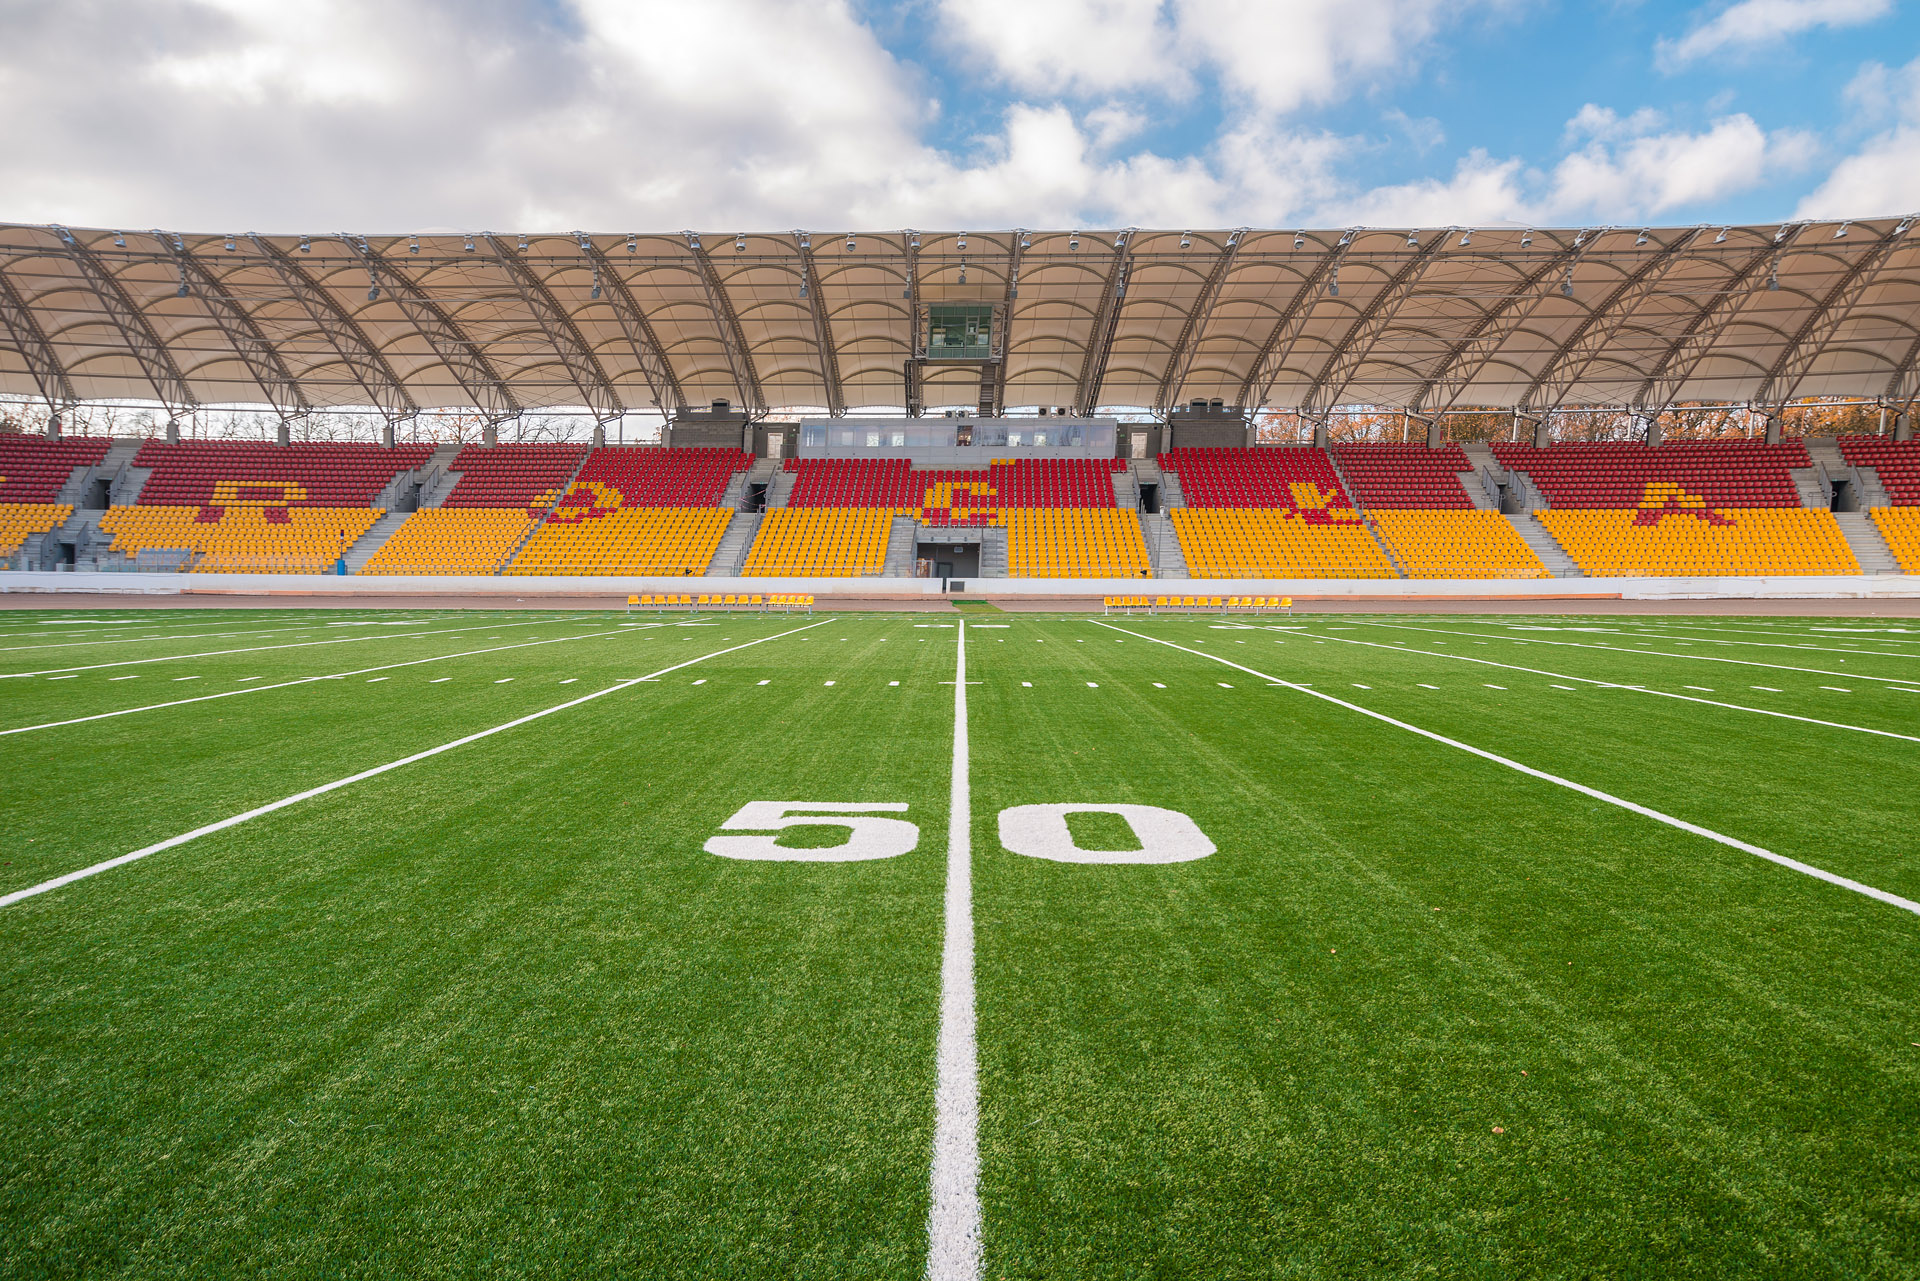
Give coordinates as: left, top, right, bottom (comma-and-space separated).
0, 0, 1920, 234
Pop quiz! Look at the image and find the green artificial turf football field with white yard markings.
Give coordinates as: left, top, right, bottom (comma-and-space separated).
0, 611, 1920, 1277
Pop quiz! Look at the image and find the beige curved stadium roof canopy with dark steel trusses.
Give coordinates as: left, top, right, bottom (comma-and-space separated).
0, 217, 1920, 419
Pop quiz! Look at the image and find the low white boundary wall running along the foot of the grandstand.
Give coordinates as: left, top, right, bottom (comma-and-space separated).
0, 572, 1920, 601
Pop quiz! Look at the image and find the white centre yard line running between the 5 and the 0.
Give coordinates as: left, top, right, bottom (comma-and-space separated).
927, 618, 985, 1281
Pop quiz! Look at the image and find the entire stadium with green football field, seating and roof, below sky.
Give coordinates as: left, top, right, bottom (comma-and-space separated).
0, 6, 1920, 1281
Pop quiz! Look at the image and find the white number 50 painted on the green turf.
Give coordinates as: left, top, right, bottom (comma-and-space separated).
705, 801, 1213, 862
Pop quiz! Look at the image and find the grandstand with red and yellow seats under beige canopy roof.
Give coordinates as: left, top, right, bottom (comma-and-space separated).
0, 217, 1920, 590
